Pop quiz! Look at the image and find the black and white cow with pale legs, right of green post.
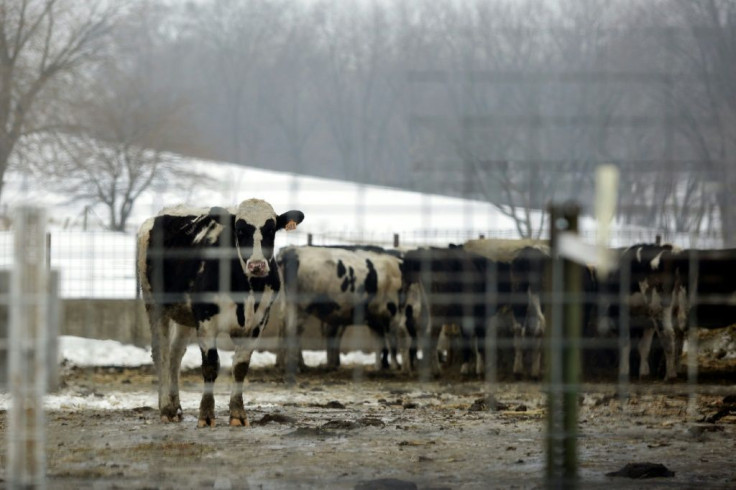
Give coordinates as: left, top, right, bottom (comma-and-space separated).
597, 243, 689, 381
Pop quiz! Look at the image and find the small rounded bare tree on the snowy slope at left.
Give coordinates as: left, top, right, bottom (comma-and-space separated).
22, 65, 202, 231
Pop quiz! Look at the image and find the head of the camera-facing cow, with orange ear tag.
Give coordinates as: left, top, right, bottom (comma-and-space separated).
234, 199, 304, 277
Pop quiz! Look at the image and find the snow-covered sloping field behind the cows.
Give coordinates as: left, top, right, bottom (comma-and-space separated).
0, 155, 718, 298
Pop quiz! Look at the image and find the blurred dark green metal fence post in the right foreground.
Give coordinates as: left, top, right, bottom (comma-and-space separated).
546, 204, 582, 488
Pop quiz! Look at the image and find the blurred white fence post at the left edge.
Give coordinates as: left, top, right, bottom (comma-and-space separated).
6, 207, 49, 488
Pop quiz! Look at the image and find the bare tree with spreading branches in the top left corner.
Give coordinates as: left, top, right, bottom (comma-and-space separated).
0, 0, 120, 199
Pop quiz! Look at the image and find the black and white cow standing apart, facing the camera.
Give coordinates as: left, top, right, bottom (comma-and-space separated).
138, 199, 304, 427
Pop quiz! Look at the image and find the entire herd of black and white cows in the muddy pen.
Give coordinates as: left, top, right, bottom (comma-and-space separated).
138, 199, 736, 426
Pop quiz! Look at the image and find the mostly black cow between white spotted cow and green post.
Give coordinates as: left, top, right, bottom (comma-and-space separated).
404, 245, 548, 378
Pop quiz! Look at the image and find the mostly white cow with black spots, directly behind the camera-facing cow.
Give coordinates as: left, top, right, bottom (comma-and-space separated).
278, 246, 427, 372
